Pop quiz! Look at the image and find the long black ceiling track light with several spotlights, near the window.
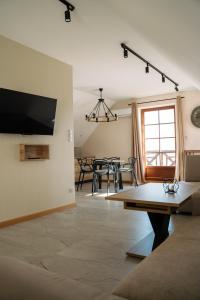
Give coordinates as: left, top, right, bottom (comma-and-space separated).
121, 43, 179, 92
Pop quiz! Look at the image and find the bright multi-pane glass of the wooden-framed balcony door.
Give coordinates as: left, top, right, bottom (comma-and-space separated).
142, 106, 176, 167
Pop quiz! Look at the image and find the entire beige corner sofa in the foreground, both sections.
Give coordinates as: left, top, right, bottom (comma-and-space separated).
0, 217, 200, 300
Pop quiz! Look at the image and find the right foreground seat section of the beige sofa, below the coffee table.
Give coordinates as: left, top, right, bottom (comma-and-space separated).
114, 235, 200, 300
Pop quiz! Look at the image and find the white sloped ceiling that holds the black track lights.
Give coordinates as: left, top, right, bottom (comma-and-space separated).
0, 0, 200, 144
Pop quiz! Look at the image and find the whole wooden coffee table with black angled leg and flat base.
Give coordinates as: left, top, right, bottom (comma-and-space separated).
106, 182, 198, 258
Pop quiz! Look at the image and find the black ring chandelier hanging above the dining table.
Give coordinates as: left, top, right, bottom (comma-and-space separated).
85, 88, 117, 122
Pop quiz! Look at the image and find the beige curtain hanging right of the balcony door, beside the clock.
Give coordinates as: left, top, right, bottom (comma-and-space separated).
175, 96, 185, 180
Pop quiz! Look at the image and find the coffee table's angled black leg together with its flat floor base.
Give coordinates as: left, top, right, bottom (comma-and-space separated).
127, 212, 170, 258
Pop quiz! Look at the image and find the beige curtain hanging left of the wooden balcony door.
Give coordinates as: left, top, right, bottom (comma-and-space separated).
132, 102, 145, 184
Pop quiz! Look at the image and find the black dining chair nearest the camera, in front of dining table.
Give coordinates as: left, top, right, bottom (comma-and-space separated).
92, 159, 116, 195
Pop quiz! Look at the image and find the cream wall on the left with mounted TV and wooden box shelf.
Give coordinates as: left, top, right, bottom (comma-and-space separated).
0, 36, 75, 221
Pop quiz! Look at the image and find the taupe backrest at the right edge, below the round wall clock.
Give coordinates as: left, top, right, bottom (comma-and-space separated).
185, 155, 200, 182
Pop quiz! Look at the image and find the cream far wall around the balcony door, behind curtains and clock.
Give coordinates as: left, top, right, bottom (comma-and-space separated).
82, 90, 200, 160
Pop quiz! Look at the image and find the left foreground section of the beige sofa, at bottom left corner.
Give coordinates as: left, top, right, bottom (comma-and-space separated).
0, 256, 121, 300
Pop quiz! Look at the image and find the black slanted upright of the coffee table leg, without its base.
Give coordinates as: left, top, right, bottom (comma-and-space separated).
148, 212, 170, 250
